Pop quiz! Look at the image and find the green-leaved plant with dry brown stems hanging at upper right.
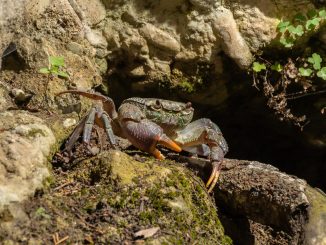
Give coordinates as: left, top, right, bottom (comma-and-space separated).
252, 9, 326, 128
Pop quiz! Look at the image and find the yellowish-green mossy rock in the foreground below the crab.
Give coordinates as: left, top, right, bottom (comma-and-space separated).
0, 150, 232, 244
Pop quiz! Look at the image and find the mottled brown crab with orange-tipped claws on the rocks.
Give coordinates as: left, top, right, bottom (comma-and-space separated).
57, 90, 228, 192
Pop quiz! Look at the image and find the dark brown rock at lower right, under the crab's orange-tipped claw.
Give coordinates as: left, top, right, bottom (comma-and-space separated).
215, 160, 326, 245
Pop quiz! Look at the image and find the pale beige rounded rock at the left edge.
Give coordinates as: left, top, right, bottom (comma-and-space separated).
0, 111, 55, 210
